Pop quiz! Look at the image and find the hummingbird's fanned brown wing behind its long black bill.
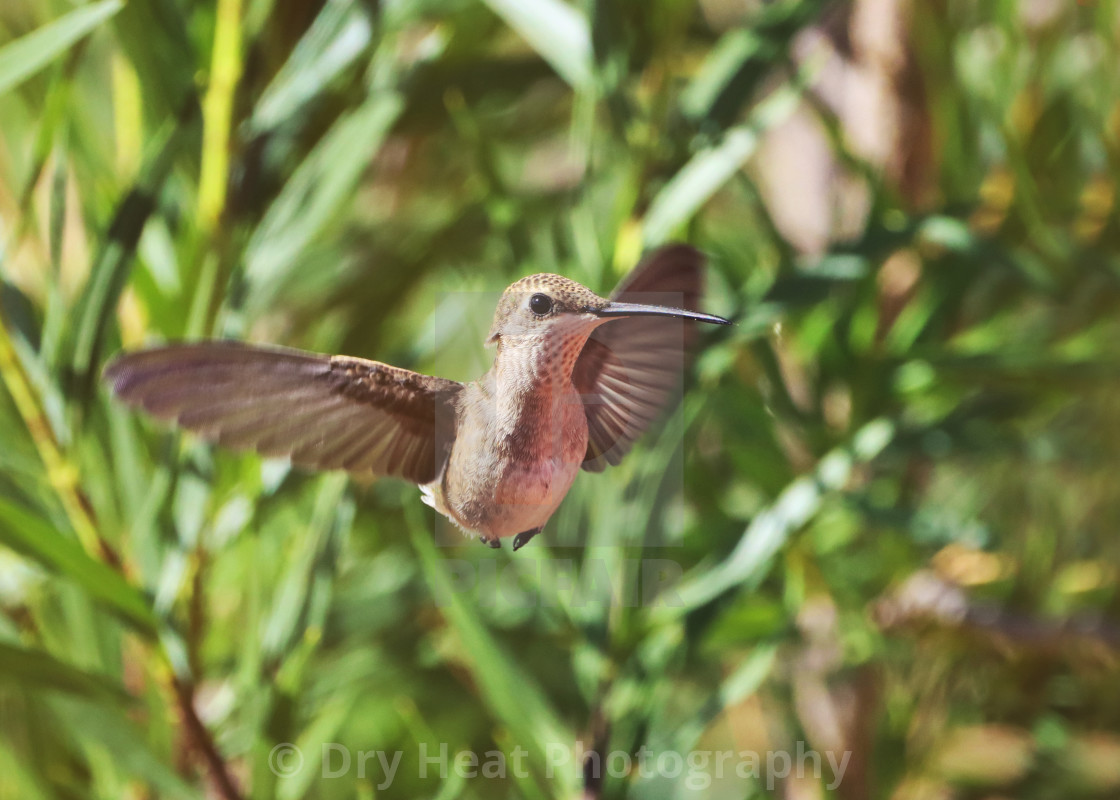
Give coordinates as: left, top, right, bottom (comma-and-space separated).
572, 239, 704, 472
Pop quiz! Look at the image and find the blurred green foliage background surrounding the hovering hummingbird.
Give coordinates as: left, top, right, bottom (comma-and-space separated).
0, 0, 1120, 800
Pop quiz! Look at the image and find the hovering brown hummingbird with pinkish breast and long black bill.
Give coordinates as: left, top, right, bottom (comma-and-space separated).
104, 244, 730, 550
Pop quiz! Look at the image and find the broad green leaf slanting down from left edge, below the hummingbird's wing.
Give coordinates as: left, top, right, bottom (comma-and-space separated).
0, 500, 159, 636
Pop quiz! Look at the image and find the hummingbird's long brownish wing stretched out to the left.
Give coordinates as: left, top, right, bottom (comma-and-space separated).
105, 342, 463, 484
